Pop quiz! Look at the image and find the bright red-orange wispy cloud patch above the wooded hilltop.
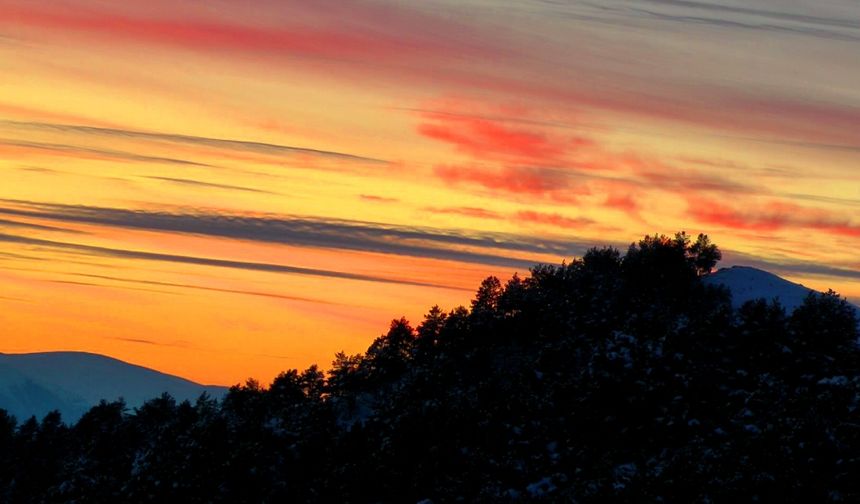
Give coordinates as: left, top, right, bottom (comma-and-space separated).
418, 105, 768, 208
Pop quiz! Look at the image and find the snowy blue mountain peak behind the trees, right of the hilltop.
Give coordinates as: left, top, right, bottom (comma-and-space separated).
704, 266, 860, 313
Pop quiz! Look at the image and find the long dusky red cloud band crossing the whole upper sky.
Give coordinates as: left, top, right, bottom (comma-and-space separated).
8, 0, 860, 149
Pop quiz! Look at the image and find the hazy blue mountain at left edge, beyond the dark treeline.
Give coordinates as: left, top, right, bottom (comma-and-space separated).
0, 352, 227, 423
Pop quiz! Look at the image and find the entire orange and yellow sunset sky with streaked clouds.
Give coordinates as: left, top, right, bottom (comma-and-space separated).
0, 0, 860, 385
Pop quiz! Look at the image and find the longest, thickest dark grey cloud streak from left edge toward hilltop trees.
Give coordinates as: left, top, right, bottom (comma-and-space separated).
0, 202, 584, 268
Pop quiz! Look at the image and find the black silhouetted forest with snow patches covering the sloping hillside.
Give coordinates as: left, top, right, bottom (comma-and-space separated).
0, 233, 860, 503
